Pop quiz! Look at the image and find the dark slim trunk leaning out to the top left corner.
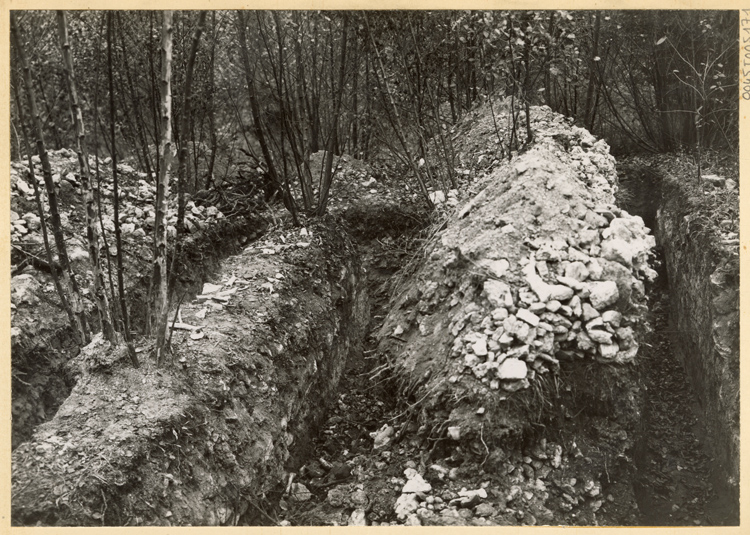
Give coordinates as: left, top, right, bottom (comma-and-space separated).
10, 11, 89, 344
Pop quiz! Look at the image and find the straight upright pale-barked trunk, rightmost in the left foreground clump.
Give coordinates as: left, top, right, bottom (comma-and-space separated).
153, 10, 174, 366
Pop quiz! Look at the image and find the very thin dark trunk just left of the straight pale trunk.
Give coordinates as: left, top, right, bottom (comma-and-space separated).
107, 11, 140, 368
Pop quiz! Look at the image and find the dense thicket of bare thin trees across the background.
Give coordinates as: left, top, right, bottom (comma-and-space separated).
11, 11, 739, 364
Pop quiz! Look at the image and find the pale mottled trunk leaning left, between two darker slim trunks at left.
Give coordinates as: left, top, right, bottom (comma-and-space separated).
57, 11, 115, 342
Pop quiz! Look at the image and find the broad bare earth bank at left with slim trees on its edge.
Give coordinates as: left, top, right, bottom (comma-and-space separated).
12, 220, 369, 526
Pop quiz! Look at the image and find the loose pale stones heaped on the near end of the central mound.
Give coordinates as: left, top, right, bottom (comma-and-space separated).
446, 207, 656, 391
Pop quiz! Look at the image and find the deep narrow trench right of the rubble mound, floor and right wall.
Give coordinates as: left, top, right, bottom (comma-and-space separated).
618, 161, 739, 526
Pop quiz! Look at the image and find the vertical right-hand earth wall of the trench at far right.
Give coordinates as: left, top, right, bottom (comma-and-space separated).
657, 173, 740, 520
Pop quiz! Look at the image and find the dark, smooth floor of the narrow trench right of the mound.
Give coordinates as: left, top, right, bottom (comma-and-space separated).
635, 288, 739, 526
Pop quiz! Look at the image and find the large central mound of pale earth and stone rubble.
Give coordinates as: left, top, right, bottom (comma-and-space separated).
379, 107, 656, 452
